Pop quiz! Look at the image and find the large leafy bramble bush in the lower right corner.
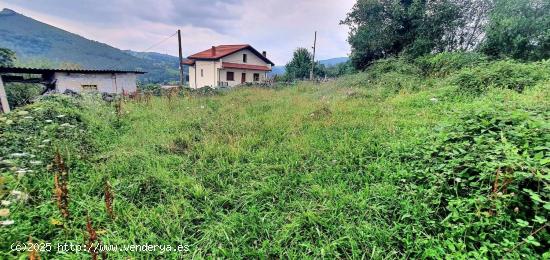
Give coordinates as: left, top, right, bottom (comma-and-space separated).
407, 107, 550, 258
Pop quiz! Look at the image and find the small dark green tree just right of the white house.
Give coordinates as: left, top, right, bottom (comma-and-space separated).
285, 48, 325, 79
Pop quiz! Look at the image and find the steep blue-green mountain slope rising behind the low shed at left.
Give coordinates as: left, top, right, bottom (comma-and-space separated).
0, 9, 179, 83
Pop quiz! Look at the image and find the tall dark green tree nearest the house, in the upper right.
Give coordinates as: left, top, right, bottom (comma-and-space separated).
341, 0, 489, 69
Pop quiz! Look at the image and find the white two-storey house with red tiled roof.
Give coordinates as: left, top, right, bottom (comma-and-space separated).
183, 44, 275, 88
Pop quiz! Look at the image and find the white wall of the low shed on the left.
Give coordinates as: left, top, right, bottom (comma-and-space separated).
54, 72, 137, 93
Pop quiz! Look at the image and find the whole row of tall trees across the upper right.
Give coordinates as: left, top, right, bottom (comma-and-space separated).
341, 0, 550, 70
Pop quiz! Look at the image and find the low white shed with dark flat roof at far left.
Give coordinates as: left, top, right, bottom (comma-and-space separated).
0, 67, 145, 112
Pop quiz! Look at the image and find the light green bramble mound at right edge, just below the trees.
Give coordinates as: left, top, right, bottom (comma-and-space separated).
452, 60, 550, 94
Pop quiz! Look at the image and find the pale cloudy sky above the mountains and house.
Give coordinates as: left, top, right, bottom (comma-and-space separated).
0, 0, 355, 65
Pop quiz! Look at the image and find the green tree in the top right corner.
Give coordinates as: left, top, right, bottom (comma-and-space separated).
481, 0, 550, 61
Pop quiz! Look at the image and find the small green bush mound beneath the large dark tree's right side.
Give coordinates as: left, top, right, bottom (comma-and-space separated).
415, 52, 487, 77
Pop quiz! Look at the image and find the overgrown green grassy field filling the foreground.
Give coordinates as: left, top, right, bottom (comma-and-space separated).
0, 56, 550, 259
